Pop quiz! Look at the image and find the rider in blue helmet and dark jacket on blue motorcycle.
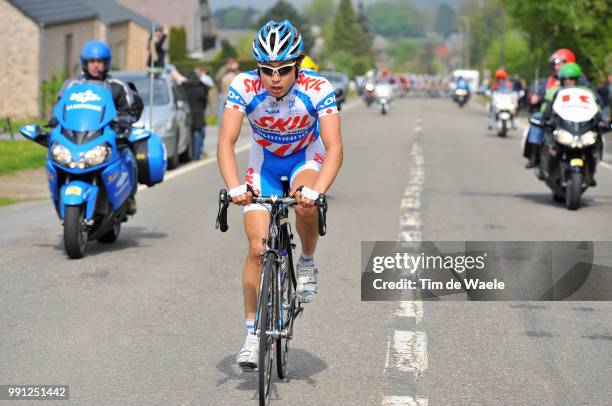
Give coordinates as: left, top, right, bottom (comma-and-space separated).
48, 40, 144, 214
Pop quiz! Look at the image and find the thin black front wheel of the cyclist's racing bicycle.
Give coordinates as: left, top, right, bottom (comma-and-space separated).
257, 255, 276, 406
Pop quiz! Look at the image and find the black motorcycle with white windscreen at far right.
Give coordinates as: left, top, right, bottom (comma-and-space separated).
529, 87, 611, 210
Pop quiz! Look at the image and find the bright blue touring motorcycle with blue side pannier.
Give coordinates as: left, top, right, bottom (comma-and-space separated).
20, 81, 166, 259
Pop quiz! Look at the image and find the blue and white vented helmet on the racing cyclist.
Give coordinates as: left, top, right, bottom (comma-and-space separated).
253, 20, 304, 63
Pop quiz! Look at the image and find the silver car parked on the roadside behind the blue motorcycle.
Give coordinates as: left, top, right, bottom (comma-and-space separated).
112, 71, 192, 169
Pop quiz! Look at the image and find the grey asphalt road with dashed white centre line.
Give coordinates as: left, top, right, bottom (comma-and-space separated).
0, 99, 612, 405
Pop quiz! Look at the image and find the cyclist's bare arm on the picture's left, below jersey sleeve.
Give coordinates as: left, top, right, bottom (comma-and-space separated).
217, 109, 244, 189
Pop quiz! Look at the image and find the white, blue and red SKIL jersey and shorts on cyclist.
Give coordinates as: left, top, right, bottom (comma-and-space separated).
225, 69, 338, 209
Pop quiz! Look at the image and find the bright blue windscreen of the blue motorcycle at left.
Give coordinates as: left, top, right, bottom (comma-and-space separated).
53, 81, 117, 132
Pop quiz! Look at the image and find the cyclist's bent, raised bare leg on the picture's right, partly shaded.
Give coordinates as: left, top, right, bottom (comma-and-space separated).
293, 169, 319, 256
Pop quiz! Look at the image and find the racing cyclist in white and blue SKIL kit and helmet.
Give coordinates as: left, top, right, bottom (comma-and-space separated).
217, 20, 342, 371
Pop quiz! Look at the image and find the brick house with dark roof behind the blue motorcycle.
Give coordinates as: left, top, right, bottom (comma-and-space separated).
0, 0, 153, 118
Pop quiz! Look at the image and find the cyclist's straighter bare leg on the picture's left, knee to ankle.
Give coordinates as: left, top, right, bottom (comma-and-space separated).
242, 210, 270, 320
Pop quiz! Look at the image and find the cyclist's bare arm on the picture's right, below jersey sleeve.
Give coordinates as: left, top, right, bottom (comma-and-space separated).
313, 114, 343, 193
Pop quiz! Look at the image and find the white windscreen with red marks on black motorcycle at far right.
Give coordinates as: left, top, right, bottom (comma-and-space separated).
553, 87, 599, 123
